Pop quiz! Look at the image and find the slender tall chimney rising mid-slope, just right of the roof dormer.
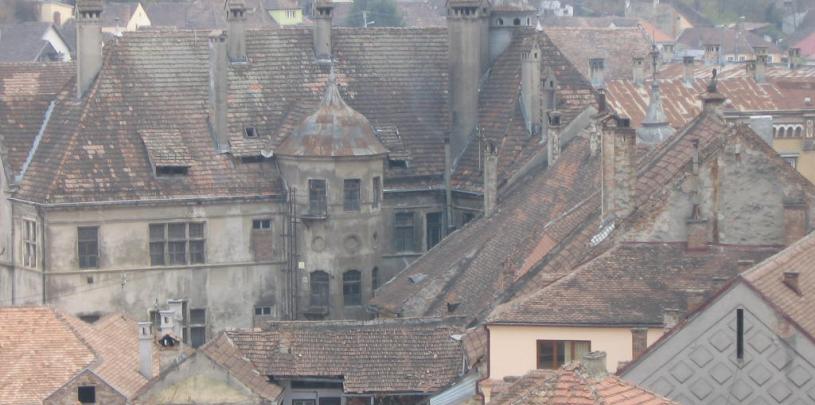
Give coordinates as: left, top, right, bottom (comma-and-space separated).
209, 30, 229, 152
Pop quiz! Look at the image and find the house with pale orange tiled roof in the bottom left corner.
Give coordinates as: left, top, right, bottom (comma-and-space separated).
0, 307, 159, 405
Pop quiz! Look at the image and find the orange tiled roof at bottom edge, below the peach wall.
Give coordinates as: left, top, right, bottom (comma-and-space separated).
490, 363, 678, 405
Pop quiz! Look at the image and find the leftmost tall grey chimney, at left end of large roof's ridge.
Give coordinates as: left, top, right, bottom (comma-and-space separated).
76, 0, 103, 98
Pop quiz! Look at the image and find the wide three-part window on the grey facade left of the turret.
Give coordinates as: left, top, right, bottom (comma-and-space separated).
150, 222, 206, 266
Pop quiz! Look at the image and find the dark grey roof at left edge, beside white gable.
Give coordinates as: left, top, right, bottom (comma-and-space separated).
0, 22, 51, 62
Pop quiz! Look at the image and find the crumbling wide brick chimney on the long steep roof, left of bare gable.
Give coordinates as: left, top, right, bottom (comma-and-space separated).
601, 117, 637, 218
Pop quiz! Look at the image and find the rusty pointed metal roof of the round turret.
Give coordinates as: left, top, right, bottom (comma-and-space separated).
275, 70, 388, 158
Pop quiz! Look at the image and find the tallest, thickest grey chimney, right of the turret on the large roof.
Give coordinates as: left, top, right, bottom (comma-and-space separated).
447, 0, 488, 160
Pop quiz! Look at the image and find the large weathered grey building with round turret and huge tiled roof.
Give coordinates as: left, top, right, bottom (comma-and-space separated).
0, 1, 595, 334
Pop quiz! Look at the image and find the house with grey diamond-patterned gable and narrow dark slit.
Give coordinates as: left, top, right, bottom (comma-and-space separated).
622, 229, 815, 404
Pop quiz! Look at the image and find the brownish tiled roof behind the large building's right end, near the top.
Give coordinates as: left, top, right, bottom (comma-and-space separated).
544, 27, 651, 81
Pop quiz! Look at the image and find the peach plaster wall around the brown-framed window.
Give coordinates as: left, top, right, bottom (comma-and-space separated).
488, 325, 664, 380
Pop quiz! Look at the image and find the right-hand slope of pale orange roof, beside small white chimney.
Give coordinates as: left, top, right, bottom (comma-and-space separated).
65, 314, 159, 398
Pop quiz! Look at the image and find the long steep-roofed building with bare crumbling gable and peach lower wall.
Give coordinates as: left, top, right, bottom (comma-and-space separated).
371, 76, 815, 388
